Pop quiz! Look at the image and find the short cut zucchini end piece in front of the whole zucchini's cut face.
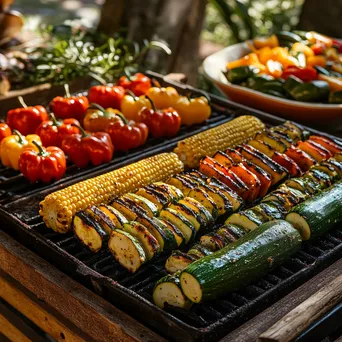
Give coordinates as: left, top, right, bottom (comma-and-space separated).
153, 274, 192, 309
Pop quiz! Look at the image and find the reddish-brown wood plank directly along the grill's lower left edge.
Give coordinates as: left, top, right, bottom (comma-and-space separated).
0, 232, 165, 342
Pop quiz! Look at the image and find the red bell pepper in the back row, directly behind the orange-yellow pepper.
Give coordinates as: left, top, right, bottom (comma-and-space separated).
88, 85, 125, 109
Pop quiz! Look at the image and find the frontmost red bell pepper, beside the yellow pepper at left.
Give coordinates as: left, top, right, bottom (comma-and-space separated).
19, 141, 66, 183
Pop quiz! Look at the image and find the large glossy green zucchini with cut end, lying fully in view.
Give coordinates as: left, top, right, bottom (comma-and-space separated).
180, 220, 302, 303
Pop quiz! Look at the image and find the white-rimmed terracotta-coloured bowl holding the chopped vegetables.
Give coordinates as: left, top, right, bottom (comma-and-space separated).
203, 43, 342, 125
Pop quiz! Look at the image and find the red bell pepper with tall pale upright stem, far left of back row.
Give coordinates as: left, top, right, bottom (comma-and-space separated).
6, 96, 49, 135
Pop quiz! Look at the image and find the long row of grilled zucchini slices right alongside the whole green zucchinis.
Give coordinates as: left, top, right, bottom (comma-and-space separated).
165, 155, 342, 273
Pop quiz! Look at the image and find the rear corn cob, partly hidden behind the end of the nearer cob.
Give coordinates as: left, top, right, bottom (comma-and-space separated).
174, 115, 265, 167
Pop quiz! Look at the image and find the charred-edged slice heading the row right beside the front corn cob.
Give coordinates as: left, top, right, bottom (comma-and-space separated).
72, 210, 108, 253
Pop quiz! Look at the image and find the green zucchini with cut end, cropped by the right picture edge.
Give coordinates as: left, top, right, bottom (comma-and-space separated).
286, 181, 342, 240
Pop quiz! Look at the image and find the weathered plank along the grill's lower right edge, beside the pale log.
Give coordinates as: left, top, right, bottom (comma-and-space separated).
221, 259, 342, 342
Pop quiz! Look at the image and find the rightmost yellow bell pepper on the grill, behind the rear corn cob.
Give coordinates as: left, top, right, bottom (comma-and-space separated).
173, 96, 211, 126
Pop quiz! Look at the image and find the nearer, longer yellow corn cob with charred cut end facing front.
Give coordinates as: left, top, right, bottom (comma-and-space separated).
39, 153, 183, 233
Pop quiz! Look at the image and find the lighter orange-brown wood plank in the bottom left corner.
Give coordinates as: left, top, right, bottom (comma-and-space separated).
0, 271, 89, 342
